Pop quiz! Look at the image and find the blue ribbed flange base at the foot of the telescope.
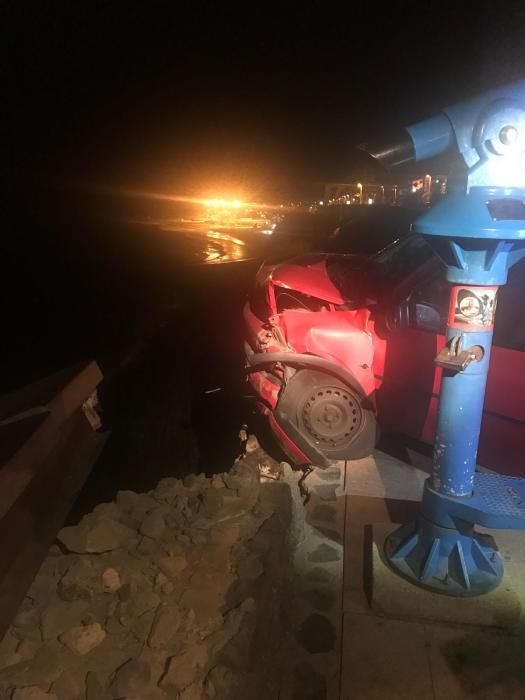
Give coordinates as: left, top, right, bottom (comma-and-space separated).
385, 518, 503, 596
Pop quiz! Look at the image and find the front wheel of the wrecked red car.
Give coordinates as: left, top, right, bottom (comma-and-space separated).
280, 369, 377, 460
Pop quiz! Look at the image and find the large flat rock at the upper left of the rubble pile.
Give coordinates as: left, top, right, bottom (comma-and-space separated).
58, 515, 136, 554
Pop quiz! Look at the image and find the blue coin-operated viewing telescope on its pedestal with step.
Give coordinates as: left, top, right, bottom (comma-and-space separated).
367, 80, 525, 596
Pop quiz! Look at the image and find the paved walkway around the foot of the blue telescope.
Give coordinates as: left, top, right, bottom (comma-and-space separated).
340, 453, 525, 700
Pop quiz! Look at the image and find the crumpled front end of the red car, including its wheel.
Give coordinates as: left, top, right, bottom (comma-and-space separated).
244, 254, 378, 467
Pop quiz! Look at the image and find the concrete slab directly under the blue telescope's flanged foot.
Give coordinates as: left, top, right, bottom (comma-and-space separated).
365, 523, 525, 628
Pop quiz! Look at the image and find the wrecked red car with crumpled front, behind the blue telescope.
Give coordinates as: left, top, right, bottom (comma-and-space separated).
244, 234, 525, 474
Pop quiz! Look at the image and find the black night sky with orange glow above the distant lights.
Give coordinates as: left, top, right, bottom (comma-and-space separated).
0, 0, 525, 202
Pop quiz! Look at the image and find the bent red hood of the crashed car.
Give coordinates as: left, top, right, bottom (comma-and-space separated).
271, 254, 384, 306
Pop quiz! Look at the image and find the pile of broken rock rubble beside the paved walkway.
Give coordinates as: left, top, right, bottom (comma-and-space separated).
0, 450, 291, 700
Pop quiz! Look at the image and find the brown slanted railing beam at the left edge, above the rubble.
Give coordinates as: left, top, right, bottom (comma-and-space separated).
0, 362, 108, 638
